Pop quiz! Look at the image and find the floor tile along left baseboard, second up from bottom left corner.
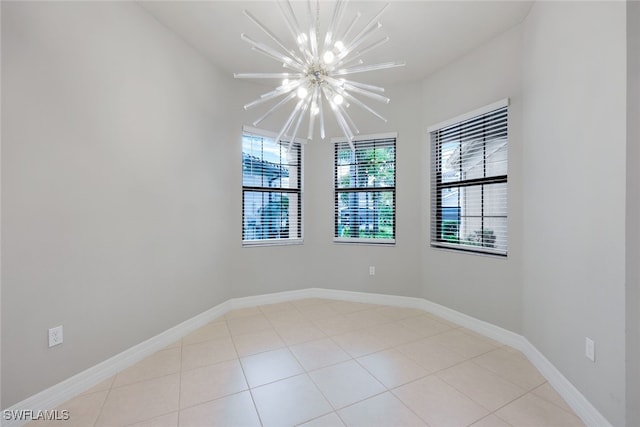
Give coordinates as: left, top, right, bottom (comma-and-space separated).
112, 347, 181, 388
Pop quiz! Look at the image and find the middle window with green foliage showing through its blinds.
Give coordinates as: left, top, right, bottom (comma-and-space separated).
334, 134, 396, 243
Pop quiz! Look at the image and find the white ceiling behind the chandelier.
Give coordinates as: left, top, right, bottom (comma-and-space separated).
139, 0, 533, 86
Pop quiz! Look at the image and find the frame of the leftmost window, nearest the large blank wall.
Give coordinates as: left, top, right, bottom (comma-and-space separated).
241, 126, 307, 247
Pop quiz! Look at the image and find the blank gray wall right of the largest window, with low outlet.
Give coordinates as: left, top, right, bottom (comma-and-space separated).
522, 2, 627, 425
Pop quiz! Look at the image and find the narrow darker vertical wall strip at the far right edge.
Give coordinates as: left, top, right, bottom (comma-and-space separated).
626, 1, 640, 426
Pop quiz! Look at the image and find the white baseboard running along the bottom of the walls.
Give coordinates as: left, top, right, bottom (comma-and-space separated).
2, 288, 611, 427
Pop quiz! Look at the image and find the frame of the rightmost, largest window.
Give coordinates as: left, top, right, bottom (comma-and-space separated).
427, 98, 510, 258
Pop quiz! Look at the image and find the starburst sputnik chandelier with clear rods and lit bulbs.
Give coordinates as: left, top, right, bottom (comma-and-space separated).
234, 0, 405, 149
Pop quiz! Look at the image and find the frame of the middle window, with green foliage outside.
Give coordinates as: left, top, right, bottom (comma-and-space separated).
331, 132, 398, 246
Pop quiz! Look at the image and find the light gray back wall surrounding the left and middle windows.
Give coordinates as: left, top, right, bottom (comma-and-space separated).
231, 84, 422, 296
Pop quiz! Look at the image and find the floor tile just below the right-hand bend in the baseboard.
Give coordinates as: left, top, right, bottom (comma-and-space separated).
473, 348, 546, 391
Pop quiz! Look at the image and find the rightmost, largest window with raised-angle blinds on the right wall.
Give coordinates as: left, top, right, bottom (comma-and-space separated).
429, 100, 508, 256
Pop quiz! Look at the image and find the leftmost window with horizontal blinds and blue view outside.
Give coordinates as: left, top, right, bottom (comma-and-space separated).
242, 129, 302, 245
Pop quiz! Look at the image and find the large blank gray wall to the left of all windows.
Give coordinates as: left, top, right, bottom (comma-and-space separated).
2, 1, 239, 407
